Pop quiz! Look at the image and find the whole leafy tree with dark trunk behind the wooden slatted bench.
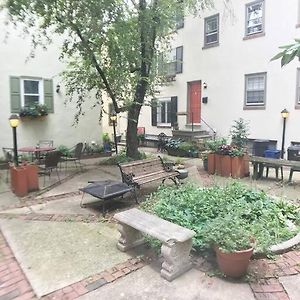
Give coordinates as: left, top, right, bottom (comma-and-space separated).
5, 0, 213, 157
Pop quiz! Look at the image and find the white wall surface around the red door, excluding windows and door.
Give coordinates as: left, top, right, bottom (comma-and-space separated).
139, 0, 300, 148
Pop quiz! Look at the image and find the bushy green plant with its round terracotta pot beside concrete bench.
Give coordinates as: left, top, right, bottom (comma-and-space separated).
205, 213, 254, 278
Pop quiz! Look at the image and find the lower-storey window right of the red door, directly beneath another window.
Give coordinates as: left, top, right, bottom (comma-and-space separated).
245, 73, 267, 107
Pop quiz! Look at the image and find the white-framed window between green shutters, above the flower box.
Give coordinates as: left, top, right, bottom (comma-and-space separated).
21, 78, 44, 107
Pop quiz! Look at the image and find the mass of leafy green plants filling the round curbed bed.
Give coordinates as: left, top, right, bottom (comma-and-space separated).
142, 182, 300, 252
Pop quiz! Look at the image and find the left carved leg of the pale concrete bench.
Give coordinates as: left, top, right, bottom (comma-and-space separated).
117, 223, 145, 252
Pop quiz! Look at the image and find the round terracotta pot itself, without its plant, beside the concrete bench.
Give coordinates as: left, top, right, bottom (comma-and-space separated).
215, 247, 253, 278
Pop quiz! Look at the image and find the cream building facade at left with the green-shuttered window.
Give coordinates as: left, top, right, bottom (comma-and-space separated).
0, 12, 102, 156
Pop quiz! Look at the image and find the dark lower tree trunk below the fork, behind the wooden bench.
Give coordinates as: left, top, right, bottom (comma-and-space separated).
126, 105, 141, 159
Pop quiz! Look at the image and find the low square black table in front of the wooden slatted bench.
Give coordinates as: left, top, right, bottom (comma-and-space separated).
79, 180, 132, 216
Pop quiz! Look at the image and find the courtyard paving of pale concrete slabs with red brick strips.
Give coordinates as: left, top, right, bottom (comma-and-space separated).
0, 154, 300, 300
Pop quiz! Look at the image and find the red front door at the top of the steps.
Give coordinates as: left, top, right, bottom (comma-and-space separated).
188, 81, 201, 123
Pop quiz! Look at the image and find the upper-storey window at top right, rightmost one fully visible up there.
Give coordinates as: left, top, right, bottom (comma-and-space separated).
246, 1, 264, 36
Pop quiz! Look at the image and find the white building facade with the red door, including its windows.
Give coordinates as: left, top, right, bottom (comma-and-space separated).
131, 0, 300, 152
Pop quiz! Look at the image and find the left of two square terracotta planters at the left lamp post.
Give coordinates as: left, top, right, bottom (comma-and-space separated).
10, 166, 28, 197
